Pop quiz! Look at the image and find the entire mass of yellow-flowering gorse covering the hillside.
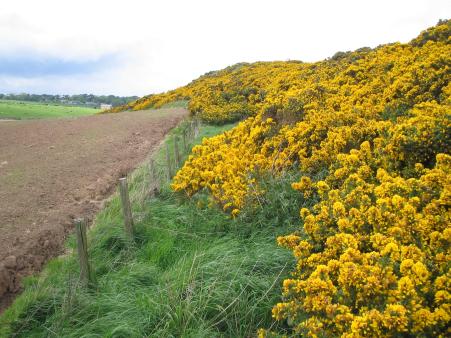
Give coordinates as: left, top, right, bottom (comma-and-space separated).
115, 21, 451, 337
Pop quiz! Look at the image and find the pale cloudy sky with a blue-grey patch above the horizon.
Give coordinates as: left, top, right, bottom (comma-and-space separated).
0, 0, 451, 96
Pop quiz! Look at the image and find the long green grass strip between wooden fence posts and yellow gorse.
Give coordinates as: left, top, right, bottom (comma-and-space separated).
0, 120, 299, 337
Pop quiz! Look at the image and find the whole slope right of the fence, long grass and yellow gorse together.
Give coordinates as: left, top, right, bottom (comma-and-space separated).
0, 20, 451, 337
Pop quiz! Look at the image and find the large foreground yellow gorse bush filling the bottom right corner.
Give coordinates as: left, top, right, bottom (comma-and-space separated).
273, 145, 451, 337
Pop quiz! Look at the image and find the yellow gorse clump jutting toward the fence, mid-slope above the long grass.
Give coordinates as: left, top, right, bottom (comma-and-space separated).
172, 116, 274, 214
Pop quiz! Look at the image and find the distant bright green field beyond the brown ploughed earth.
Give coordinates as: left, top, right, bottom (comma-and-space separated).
0, 100, 99, 120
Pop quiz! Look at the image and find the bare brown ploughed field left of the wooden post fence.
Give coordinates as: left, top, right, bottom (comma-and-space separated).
0, 109, 187, 312
